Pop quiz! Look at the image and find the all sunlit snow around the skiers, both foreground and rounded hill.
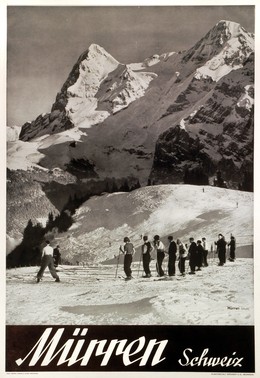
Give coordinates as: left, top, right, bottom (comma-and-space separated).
6, 185, 254, 325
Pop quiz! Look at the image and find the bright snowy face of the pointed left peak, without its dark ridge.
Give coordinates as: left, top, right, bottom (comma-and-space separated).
64, 45, 154, 127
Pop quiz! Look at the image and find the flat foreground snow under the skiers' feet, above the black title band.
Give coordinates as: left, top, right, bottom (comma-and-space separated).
6, 258, 254, 325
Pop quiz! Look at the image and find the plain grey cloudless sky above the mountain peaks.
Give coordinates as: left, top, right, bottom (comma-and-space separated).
6, 5, 255, 126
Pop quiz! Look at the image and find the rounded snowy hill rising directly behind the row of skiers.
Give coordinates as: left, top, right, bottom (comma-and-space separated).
56, 185, 253, 263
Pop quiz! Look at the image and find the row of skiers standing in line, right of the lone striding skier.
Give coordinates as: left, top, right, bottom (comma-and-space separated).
120, 234, 236, 280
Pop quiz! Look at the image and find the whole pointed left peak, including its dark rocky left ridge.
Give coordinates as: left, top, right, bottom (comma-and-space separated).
20, 44, 156, 141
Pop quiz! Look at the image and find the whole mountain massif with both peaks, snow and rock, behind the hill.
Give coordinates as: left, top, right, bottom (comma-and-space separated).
7, 21, 254, 250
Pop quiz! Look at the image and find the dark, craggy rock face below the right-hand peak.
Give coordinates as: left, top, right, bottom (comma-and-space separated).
150, 54, 254, 188
